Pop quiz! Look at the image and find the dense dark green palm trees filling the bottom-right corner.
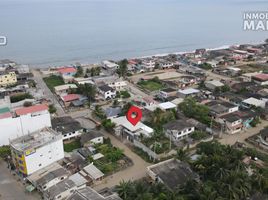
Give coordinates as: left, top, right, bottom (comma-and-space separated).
116, 141, 268, 200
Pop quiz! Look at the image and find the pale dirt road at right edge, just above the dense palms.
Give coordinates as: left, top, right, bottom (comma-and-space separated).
219, 121, 268, 145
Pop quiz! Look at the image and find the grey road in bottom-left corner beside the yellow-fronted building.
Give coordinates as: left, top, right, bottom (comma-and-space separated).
0, 160, 41, 200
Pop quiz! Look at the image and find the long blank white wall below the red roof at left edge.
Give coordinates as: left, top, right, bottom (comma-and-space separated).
0, 111, 51, 146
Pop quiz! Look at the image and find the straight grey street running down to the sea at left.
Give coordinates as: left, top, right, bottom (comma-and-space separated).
32, 70, 65, 116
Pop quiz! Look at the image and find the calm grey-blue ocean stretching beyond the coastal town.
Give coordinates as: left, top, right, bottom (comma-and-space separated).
0, 0, 268, 67
